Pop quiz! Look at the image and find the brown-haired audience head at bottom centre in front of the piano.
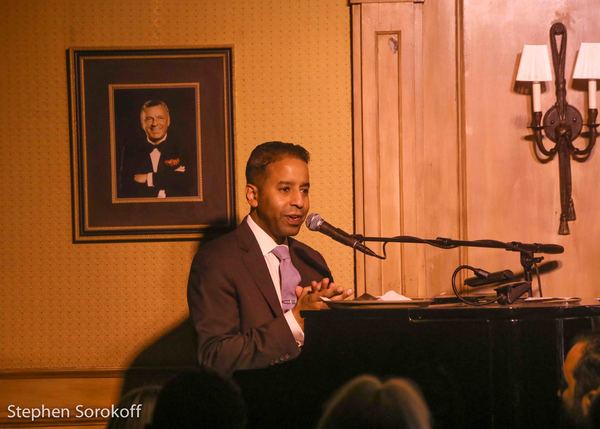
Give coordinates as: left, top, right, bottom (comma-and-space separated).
317, 375, 431, 429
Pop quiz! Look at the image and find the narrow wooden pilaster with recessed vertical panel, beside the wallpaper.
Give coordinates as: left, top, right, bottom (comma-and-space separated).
354, 3, 420, 294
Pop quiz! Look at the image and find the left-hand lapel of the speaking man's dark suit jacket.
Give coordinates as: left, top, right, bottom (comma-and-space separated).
236, 219, 283, 315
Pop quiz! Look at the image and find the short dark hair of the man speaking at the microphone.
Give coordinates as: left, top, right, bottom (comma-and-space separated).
246, 141, 310, 185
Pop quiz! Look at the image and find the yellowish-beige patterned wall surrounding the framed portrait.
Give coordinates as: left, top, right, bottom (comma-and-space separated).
0, 0, 354, 369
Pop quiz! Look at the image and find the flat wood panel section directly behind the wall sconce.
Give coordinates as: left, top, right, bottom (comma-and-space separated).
463, 0, 600, 297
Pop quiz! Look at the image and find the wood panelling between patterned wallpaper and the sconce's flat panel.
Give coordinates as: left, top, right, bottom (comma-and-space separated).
352, 2, 459, 296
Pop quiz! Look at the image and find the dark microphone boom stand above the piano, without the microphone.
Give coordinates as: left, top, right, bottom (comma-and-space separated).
352, 234, 564, 304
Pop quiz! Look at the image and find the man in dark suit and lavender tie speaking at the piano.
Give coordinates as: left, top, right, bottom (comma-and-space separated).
188, 142, 352, 374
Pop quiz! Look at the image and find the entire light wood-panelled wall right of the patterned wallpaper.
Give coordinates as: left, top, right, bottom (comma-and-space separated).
352, 0, 600, 297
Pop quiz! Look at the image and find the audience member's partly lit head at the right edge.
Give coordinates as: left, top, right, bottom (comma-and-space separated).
559, 331, 600, 428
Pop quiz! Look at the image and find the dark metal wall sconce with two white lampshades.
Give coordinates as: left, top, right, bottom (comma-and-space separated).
517, 22, 600, 235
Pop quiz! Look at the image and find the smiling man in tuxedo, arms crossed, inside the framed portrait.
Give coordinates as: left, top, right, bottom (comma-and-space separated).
118, 99, 193, 198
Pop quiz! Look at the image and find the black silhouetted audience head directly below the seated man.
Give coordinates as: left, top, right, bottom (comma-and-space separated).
151, 369, 246, 429
